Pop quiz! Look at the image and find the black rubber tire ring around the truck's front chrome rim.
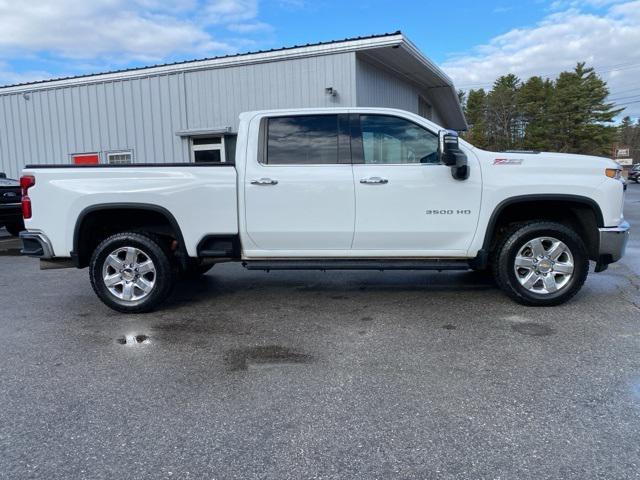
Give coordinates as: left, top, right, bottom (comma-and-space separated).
492, 221, 589, 307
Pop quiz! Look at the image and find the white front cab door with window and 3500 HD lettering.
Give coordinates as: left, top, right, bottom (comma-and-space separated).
353, 114, 481, 257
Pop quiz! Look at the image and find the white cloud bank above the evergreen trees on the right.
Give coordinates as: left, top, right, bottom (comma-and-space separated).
443, 0, 640, 116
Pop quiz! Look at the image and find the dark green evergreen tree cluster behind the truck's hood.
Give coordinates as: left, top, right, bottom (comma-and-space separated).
460, 63, 624, 156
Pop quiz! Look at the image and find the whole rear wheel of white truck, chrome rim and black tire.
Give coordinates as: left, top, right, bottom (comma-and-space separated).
89, 232, 174, 313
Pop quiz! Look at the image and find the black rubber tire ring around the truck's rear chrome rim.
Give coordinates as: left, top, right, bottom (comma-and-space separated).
89, 232, 175, 313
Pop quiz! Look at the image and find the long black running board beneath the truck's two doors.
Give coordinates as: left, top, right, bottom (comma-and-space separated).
242, 259, 471, 271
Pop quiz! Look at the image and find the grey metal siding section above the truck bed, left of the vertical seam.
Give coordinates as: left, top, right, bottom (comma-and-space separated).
0, 73, 189, 178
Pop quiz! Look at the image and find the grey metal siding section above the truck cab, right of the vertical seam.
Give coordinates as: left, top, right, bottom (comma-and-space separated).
185, 53, 355, 130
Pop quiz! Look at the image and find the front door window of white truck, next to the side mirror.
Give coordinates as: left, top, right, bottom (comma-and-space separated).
360, 115, 439, 164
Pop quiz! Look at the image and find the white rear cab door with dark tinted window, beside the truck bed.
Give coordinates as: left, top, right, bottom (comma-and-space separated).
244, 114, 355, 256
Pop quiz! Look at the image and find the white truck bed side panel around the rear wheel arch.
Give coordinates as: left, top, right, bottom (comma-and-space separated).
23, 163, 238, 257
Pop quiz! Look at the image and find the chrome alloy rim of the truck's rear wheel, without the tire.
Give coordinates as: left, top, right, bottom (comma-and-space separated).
102, 247, 156, 302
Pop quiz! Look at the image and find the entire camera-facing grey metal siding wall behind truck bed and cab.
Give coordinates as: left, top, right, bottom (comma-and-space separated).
0, 52, 358, 178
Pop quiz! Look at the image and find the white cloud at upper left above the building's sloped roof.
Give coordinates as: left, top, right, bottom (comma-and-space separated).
0, 0, 268, 62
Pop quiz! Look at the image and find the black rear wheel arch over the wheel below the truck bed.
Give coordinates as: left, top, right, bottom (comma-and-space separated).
71, 203, 188, 268
